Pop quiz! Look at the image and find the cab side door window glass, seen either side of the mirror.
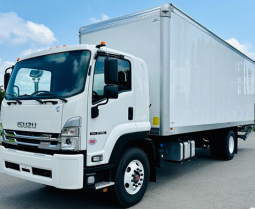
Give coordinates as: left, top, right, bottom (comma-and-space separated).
92, 56, 131, 103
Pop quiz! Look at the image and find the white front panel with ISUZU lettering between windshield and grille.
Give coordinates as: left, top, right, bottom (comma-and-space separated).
1, 100, 63, 133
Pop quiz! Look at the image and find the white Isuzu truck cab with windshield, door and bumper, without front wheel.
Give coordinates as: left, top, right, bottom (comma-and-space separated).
0, 44, 151, 207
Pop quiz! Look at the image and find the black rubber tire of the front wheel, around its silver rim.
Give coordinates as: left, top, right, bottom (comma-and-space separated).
115, 148, 150, 208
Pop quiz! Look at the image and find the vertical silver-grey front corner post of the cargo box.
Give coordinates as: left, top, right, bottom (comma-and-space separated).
160, 4, 173, 136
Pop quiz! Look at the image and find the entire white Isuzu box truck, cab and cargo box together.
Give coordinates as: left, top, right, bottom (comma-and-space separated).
0, 4, 255, 207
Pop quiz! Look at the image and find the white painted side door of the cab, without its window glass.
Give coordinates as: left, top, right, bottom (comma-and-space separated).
87, 55, 135, 155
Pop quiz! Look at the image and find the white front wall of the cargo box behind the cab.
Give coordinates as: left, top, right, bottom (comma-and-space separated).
81, 14, 160, 128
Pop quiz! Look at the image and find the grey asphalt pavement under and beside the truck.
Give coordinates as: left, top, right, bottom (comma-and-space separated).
0, 132, 255, 209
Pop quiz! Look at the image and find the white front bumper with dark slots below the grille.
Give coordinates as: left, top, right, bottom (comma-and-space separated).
0, 146, 84, 189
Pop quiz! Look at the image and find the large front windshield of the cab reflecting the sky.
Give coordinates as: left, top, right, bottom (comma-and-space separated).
6, 50, 90, 99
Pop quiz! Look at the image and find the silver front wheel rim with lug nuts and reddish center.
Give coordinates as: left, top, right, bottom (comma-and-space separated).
124, 160, 144, 194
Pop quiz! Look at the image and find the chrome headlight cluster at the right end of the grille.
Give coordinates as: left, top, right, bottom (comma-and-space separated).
61, 117, 81, 150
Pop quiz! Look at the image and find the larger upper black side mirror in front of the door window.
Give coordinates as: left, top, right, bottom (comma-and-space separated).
104, 58, 118, 85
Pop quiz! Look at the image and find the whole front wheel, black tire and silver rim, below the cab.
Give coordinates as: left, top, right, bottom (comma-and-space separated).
115, 148, 150, 207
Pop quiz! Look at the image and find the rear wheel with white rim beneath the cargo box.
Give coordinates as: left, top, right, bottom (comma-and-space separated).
222, 130, 236, 160
